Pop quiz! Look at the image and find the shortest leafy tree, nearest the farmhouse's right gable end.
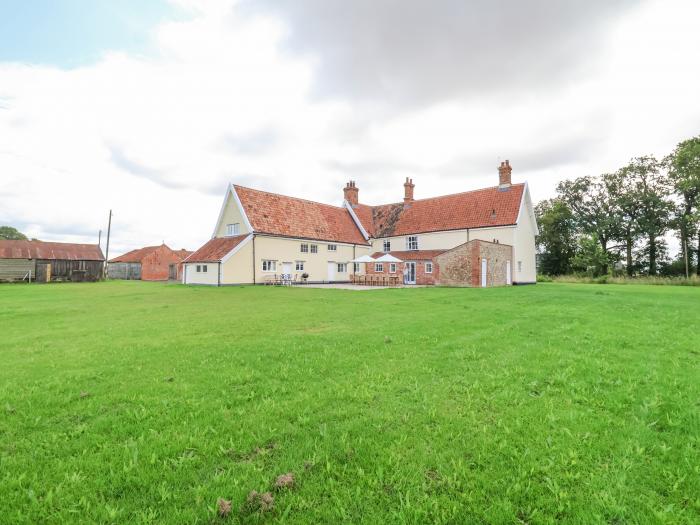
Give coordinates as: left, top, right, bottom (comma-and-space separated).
535, 199, 576, 275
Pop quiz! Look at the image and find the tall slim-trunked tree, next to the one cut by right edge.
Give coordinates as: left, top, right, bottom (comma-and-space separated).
624, 156, 673, 275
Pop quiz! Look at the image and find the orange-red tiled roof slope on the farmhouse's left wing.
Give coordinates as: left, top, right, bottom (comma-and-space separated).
234, 186, 367, 244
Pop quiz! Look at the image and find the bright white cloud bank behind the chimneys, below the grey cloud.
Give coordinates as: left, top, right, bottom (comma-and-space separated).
0, 0, 700, 253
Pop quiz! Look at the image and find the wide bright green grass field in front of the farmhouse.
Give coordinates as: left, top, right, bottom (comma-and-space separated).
0, 282, 700, 524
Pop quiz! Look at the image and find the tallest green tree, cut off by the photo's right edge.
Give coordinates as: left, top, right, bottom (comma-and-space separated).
665, 136, 700, 275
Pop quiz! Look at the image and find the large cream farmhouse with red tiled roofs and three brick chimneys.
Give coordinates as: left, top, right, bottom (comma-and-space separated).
183, 161, 537, 286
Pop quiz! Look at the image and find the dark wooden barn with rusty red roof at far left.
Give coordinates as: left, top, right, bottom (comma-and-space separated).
0, 240, 105, 282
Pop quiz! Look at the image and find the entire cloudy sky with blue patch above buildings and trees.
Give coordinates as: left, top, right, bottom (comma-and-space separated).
0, 0, 700, 256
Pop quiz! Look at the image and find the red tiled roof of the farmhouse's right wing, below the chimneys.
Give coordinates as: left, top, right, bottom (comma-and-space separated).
354, 184, 525, 238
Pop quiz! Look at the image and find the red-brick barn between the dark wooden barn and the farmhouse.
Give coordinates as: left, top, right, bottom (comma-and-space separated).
107, 244, 192, 281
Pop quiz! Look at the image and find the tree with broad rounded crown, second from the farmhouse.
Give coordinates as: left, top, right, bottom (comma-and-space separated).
557, 177, 620, 273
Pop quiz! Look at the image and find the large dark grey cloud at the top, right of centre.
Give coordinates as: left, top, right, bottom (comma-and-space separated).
240, 0, 641, 104
